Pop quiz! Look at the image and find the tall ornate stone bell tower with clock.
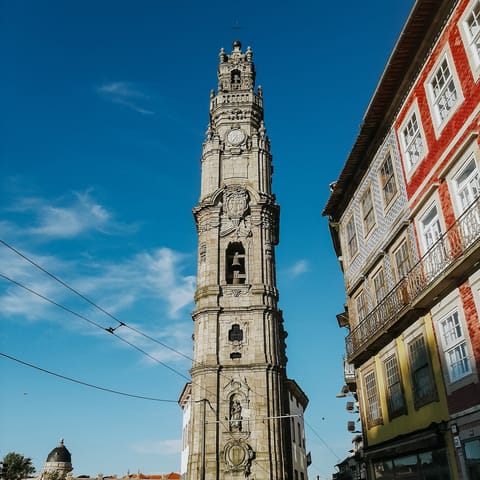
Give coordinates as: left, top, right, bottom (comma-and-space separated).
180, 41, 308, 480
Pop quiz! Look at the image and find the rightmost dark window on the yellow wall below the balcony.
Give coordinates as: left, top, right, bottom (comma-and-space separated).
408, 335, 437, 408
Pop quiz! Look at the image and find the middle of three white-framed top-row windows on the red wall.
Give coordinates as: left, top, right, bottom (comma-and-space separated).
427, 54, 461, 127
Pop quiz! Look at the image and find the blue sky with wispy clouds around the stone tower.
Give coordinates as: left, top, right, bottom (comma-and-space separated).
0, 0, 413, 479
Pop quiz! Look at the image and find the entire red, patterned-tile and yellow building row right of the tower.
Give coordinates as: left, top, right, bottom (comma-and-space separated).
323, 0, 480, 480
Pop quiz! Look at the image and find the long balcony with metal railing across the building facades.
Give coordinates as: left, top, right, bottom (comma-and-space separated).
346, 199, 480, 364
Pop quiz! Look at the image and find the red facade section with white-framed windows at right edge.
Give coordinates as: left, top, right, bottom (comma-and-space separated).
395, 0, 480, 479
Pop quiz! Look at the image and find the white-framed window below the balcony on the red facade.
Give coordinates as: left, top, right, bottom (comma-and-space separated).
439, 310, 472, 383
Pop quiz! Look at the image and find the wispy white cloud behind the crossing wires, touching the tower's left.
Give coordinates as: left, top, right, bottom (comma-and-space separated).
0, 242, 195, 364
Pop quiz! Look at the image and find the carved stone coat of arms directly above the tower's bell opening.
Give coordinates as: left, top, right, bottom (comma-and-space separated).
220, 186, 251, 237
